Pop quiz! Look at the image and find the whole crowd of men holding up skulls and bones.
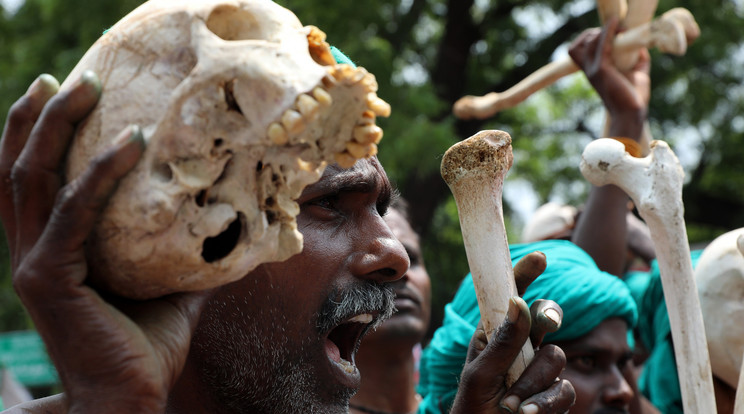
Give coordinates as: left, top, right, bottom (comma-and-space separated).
0, 1, 744, 414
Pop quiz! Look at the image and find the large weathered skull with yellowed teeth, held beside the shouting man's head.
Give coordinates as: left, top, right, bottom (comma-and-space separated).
62, 0, 390, 299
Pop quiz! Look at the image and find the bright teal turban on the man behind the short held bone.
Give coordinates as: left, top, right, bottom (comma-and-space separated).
418, 240, 638, 413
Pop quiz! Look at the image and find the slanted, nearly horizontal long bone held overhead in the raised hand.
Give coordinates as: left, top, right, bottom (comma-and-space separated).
453, 7, 700, 119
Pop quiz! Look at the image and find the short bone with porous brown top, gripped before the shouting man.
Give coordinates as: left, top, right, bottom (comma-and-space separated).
441, 131, 534, 385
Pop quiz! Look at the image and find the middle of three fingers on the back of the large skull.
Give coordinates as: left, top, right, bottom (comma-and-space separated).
11, 72, 101, 259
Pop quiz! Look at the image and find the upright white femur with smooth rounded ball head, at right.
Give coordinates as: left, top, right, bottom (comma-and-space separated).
581, 138, 716, 414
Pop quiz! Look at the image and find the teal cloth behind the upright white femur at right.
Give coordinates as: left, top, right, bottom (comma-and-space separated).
634, 250, 703, 414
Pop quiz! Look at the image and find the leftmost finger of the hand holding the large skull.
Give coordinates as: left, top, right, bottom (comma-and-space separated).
0, 74, 59, 258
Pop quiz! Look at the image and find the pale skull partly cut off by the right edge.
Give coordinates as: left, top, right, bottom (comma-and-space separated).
695, 228, 744, 388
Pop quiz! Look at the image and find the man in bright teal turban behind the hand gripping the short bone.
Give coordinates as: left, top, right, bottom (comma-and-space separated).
419, 240, 637, 413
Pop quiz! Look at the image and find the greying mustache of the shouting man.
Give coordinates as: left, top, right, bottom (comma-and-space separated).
317, 282, 395, 333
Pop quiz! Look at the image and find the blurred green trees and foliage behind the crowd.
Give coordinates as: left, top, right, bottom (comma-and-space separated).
0, 0, 744, 342
